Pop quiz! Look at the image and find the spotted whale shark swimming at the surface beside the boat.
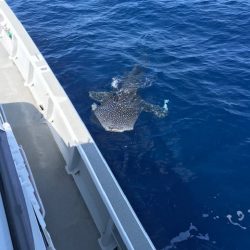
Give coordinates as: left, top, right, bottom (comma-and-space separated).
89, 65, 168, 132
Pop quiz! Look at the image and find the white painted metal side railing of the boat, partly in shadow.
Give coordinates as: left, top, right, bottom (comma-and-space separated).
0, 0, 155, 250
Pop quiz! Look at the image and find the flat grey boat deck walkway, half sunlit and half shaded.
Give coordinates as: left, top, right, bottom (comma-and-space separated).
0, 40, 100, 250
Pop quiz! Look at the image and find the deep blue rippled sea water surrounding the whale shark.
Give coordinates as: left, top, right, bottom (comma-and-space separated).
8, 0, 250, 250
